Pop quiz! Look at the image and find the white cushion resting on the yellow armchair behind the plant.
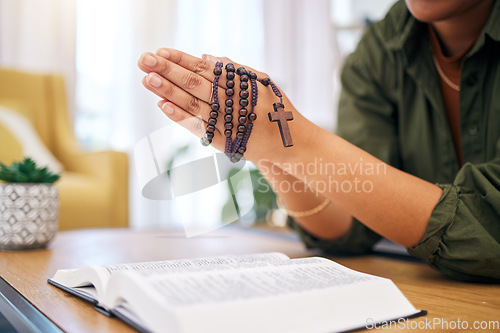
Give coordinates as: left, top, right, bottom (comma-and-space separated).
0, 105, 63, 173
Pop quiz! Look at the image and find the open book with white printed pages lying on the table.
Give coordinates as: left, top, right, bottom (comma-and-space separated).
48, 253, 424, 333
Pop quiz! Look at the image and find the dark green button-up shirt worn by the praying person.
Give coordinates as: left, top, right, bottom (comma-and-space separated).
297, 1, 500, 282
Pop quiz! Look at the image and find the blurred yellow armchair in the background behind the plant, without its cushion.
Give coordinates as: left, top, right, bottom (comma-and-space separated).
0, 68, 128, 230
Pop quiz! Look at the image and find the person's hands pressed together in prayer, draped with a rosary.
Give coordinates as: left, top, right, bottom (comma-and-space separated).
138, 48, 305, 162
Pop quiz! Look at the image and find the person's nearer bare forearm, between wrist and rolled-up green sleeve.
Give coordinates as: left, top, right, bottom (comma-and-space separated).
260, 118, 442, 247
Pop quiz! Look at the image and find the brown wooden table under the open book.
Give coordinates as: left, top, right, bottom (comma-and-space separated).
0, 227, 500, 332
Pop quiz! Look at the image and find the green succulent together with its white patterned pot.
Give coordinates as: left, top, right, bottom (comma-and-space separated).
0, 158, 60, 250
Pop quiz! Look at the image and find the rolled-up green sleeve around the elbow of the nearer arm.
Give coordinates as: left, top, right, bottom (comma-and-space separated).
408, 158, 500, 282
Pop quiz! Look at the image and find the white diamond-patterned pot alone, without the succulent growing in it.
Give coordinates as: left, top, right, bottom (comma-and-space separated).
0, 183, 59, 250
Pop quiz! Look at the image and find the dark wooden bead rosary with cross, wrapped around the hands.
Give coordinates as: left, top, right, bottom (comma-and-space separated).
201, 61, 293, 163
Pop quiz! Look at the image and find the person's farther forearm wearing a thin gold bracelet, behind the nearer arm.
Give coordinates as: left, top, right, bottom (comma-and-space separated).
257, 160, 352, 239
